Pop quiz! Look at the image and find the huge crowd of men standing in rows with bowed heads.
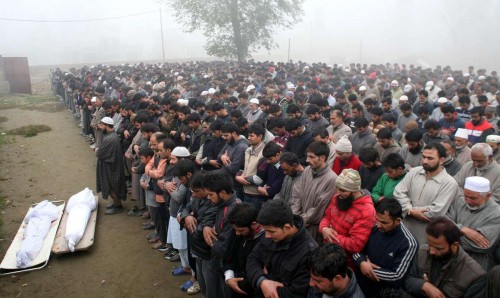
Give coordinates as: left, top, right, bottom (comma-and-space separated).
51, 61, 500, 298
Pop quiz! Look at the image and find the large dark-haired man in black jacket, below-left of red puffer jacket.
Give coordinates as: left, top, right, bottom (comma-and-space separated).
247, 200, 318, 297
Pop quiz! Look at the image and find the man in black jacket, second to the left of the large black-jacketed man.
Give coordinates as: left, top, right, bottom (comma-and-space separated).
203, 171, 239, 298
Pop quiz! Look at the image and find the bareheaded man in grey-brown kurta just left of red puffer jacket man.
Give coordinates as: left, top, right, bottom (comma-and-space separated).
291, 142, 337, 240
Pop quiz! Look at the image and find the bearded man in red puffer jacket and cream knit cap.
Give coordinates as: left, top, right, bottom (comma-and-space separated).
319, 169, 375, 270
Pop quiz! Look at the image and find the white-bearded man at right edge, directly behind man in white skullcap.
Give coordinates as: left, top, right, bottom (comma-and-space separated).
454, 143, 500, 203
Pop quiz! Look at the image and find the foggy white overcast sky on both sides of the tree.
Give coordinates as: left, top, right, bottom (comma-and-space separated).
0, 0, 500, 71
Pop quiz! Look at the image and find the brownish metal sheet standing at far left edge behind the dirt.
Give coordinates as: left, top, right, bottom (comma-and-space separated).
3, 57, 31, 94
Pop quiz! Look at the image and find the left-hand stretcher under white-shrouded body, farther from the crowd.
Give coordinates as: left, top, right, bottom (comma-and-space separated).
0, 201, 66, 275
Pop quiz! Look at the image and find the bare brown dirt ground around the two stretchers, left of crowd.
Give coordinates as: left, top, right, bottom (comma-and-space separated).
0, 67, 201, 297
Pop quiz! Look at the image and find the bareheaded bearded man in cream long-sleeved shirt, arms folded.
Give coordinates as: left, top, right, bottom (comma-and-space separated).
394, 144, 459, 244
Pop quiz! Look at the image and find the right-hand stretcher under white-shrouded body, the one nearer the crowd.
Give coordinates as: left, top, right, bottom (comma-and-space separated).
52, 197, 99, 254
